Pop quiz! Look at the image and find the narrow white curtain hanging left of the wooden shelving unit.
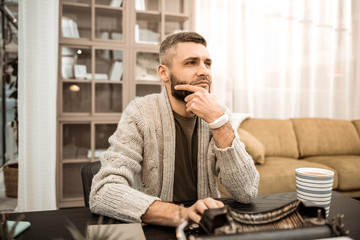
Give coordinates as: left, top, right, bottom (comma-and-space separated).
17, 0, 59, 211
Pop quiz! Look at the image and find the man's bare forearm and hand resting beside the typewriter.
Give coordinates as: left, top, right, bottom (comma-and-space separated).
141, 198, 224, 227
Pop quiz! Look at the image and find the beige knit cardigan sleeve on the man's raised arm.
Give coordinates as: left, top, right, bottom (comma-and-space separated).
211, 109, 259, 203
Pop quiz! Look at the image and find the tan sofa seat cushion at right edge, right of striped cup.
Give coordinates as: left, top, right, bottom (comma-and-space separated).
304, 155, 360, 191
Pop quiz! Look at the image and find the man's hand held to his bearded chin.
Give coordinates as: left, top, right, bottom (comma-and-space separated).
174, 85, 224, 123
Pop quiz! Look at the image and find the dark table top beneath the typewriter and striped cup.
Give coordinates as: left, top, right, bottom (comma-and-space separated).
7, 192, 360, 240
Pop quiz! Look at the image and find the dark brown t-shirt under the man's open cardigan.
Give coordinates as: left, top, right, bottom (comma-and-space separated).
173, 111, 198, 202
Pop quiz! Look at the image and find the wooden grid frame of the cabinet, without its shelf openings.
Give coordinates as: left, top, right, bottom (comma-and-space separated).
56, 0, 195, 208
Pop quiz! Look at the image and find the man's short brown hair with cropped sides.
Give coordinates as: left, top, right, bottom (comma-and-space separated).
159, 32, 206, 67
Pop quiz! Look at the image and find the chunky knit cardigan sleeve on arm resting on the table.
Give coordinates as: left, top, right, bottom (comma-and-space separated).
90, 103, 160, 222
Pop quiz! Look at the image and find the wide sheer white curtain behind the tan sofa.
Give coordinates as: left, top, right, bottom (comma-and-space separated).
195, 0, 360, 119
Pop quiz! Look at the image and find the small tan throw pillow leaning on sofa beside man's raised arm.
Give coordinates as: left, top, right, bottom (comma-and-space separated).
238, 128, 265, 164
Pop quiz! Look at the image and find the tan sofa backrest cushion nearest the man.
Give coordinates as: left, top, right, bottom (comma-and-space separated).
240, 118, 299, 158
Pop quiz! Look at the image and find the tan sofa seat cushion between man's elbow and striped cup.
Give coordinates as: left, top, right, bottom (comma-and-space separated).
256, 157, 338, 194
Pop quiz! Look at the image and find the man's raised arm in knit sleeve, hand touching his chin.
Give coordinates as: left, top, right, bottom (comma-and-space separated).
175, 85, 259, 203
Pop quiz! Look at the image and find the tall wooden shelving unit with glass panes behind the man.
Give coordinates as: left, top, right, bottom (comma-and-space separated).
57, 0, 194, 208
